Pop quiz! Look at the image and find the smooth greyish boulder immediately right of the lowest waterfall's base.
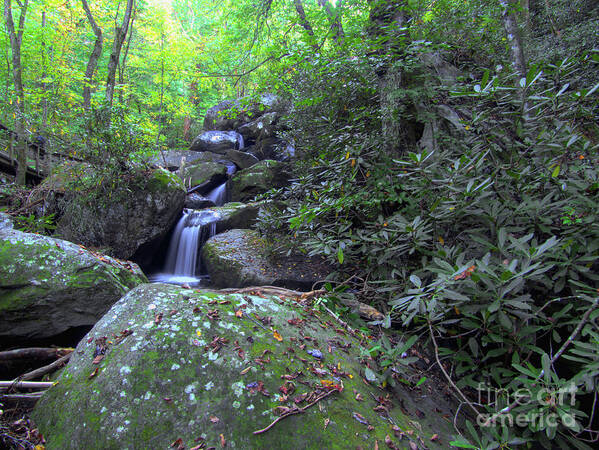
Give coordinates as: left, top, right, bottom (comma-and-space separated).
202, 229, 328, 290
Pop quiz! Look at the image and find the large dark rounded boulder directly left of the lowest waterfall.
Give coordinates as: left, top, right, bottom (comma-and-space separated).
56, 169, 186, 259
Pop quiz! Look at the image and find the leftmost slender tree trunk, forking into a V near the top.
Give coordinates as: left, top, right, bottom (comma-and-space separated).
4, 0, 29, 185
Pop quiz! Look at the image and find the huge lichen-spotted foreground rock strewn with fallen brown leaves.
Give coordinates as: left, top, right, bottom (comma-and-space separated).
33, 284, 453, 450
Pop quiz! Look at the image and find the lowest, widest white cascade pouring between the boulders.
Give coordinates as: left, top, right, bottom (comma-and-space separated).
152, 208, 220, 284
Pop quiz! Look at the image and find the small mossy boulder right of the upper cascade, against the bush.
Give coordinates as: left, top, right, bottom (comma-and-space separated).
231, 160, 290, 202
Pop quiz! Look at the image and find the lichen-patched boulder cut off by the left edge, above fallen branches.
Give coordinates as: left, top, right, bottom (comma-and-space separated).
0, 228, 147, 339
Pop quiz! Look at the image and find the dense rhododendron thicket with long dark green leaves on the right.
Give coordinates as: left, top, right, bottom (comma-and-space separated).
262, 44, 599, 448
